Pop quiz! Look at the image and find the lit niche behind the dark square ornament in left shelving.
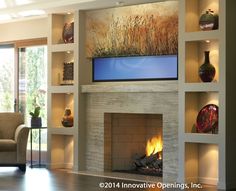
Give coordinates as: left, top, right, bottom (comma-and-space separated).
51, 51, 74, 86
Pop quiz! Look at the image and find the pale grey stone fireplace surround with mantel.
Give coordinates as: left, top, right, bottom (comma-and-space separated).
81, 81, 178, 182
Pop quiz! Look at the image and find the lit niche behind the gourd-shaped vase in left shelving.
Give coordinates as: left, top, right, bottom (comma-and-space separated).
51, 93, 74, 128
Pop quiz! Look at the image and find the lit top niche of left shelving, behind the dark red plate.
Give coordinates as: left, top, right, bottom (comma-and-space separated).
52, 14, 74, 44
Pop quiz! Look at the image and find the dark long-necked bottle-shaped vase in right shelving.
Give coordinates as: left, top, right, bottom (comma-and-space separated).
199, 51, 216, 82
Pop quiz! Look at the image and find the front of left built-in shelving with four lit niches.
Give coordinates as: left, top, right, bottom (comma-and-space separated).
48, 12, 79, 168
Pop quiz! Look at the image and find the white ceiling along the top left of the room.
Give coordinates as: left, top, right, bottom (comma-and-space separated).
0, 0, 160, 24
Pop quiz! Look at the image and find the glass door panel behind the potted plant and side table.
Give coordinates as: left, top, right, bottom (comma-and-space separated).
19, 46, 47, 155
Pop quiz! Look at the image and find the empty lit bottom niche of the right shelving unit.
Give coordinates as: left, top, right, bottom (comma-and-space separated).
185, 143, 219, 186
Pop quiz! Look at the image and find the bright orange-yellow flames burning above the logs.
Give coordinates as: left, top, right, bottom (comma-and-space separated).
146, 136, 162, 159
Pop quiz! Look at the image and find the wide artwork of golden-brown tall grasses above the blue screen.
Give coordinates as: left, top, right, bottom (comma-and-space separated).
86, 1, 178, 57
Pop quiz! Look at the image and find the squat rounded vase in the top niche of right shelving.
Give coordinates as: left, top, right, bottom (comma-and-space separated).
199, 9, 218, 31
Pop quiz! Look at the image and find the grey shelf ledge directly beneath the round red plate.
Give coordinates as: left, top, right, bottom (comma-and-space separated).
184, 133, 219, 144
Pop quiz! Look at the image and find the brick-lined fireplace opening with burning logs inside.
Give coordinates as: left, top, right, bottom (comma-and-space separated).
104, 113, 163, 176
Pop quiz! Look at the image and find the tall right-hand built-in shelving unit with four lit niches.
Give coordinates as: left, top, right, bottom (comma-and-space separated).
179, 0, 225, 188
